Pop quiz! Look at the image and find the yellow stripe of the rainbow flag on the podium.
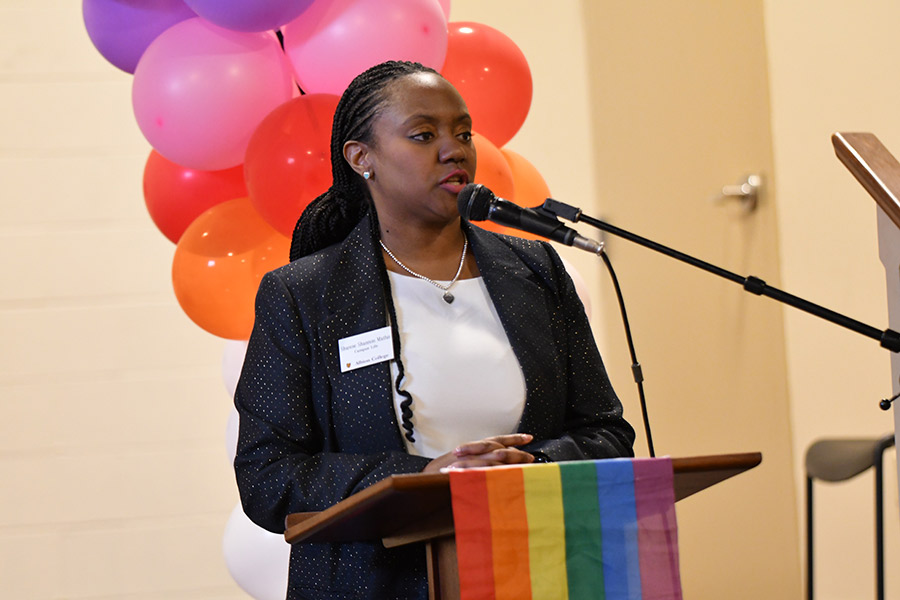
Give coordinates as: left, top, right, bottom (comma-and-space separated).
522, 464, 569, 600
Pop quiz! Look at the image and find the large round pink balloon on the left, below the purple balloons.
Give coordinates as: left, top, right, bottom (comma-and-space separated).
131, 18, 294, 171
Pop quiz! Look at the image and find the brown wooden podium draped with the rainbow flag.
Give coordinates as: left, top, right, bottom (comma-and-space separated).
284, 452, 762, 600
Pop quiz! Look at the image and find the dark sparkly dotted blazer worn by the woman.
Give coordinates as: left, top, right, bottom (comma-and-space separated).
234, 217, 634, 600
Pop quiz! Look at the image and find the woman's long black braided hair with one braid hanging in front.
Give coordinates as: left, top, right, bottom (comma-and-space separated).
290, 61, 440, 442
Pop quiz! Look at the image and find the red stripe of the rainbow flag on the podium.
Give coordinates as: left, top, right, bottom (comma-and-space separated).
450, 470, 496, 600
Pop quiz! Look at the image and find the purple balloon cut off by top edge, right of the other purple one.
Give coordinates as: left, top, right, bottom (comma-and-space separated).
184, 0, 313, 31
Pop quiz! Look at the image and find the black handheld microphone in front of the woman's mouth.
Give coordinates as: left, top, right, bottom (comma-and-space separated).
457, 183, 603, 254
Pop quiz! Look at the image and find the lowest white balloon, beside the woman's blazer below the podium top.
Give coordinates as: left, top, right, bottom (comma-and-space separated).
222, 504, 291, 600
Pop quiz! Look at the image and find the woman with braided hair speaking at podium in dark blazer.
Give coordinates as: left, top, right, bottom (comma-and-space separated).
234, 62, 634, 600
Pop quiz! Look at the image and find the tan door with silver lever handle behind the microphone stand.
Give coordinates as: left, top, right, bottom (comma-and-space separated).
582, 0, 801, 600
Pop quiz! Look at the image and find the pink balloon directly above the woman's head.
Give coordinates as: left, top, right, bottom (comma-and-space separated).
281, 0, 447, 95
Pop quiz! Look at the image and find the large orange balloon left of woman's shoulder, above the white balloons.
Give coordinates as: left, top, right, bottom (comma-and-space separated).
172, 198, 291, 340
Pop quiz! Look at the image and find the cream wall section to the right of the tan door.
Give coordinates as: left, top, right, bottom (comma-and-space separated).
765, 0, 900, 598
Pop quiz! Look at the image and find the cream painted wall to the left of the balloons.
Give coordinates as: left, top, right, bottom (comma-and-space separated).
0, 0, 246, 600
